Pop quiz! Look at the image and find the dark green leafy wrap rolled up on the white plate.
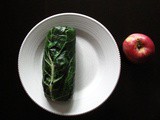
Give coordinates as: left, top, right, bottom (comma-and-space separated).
42, 26, 76, 101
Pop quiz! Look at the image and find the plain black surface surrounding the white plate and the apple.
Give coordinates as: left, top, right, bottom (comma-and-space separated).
0, 0, 160, 120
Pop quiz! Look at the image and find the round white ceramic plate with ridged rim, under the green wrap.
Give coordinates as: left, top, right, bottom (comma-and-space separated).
18, 13, 120, 115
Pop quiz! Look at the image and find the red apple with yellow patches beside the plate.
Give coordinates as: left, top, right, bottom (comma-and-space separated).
123, 33, 155, 63
